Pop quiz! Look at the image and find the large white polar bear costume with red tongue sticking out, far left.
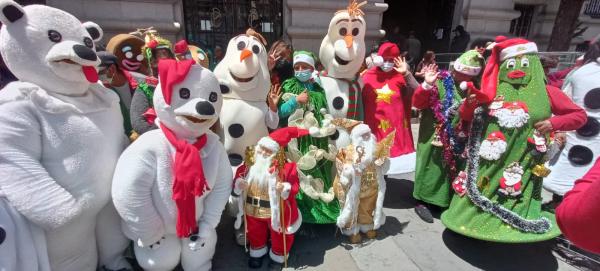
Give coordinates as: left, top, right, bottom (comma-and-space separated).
0, 0, 129, 271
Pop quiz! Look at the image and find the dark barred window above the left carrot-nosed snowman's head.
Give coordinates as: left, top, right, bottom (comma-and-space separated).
183, 0, 283, 51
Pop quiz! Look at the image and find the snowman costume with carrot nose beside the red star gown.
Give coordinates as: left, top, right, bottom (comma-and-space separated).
319, 2, 367, 149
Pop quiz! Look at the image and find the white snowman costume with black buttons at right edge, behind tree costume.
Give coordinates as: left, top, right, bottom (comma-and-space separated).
544, 62, 600, 195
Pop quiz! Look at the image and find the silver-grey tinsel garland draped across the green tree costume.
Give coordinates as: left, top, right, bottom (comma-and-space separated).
466, 107, 552, 234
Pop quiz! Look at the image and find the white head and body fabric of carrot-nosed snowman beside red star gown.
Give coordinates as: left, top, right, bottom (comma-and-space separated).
319, 11, 366, 149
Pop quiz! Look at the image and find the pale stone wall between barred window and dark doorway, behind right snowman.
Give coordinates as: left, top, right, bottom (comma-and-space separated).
283, 0, 388, 54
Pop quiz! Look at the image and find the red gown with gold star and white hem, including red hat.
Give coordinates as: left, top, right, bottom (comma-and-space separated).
362, 42, 415, 176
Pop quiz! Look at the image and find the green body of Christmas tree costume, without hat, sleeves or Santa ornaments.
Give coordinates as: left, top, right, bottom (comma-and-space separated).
442, 54, 560, 243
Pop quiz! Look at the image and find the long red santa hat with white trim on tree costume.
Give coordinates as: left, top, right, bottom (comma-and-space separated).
481, 36, 538, 100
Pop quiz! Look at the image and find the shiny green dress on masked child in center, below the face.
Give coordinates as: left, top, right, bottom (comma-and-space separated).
278, 77, 340, 224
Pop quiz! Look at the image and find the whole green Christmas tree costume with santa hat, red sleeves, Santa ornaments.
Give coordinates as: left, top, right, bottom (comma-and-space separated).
442, 37, 585, 243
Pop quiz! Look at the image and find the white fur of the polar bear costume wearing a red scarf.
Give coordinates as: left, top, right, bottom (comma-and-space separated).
112, 65, 232, 270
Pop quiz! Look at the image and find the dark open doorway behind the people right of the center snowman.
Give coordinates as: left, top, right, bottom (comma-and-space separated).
382, 0, 456, 58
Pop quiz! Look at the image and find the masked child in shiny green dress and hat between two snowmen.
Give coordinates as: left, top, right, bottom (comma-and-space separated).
278, 51, 339, 224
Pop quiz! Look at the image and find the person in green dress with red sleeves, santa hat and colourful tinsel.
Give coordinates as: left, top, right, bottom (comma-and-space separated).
412, 50, 483, 223
